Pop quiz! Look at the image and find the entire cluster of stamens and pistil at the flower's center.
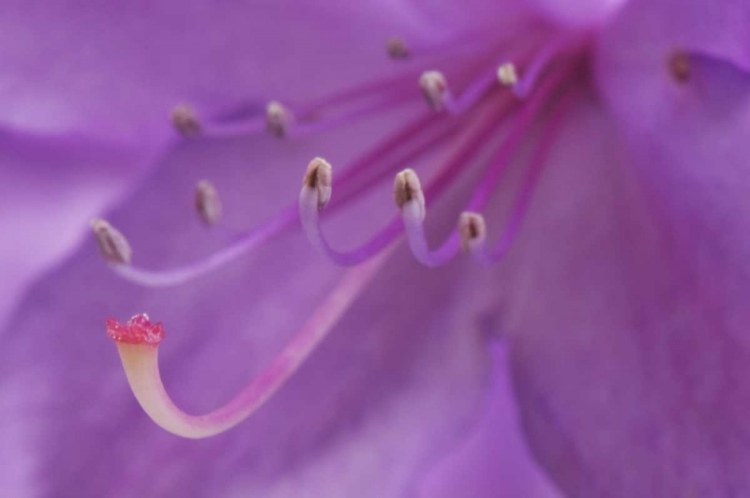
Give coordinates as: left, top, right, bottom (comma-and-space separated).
101, 17, 588, 437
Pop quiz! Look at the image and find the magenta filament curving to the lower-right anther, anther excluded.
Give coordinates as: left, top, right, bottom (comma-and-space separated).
471, 87, 573, 264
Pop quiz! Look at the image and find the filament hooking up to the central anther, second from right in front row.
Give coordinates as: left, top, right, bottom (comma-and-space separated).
402, 70, 570, 267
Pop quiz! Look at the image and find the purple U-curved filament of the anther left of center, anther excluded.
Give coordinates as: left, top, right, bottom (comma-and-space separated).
299, 94, 511, 266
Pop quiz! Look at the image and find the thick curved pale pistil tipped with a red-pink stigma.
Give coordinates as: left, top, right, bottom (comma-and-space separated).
107, 251, 390, 439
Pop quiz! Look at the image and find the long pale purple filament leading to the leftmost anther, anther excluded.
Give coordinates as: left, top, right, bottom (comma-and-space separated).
110, 113, 452, 287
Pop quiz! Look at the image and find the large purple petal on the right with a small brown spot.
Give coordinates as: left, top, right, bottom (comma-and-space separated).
504, 12, 750, 490
